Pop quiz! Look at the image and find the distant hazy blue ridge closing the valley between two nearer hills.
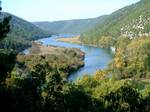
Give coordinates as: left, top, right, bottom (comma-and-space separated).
33, 15, 107, 33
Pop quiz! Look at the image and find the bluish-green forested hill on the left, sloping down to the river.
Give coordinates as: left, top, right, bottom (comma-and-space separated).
0, 12, 50, 50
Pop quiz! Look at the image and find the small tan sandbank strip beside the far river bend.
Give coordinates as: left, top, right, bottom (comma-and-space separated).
57, 35, 82, 44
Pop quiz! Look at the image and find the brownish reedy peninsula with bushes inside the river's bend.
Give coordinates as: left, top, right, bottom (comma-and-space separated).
17, 41, 85, 80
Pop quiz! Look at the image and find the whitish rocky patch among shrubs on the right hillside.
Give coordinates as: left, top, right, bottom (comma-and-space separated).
120, 10, 150, 39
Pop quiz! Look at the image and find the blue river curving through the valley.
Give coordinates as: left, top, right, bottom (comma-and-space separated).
39, 34, 112, 81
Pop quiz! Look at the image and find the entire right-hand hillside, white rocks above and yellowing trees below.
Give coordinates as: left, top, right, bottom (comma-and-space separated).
81, 0, 150, 80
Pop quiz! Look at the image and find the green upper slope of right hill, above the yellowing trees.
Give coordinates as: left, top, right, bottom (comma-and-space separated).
81, 0, 150, 44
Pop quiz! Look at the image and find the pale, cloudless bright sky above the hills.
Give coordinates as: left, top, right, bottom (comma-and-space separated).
1, 0, 140, 21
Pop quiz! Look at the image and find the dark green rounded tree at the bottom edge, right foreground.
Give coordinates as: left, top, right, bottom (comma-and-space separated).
104, 85, 142, 112
